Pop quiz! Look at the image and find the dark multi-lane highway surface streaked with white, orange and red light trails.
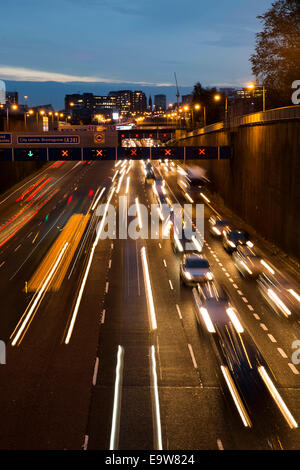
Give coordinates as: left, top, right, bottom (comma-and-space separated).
0, 161, 300, 450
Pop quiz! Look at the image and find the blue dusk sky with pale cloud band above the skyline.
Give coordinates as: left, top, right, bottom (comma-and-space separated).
0, 0, 272, 105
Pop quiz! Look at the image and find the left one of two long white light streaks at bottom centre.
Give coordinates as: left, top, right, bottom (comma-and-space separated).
109, 345, 124, 450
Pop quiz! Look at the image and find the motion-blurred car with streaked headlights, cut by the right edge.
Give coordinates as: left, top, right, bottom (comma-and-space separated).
257, 272, 300, 321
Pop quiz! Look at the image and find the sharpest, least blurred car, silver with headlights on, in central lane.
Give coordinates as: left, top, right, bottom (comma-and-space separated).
180, 253, 213, 286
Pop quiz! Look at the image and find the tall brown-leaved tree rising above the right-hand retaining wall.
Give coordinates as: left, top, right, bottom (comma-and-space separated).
250, 0, 300, 107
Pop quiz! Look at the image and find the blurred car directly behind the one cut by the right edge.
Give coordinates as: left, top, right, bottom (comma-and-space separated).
232, 245, 263, 278
